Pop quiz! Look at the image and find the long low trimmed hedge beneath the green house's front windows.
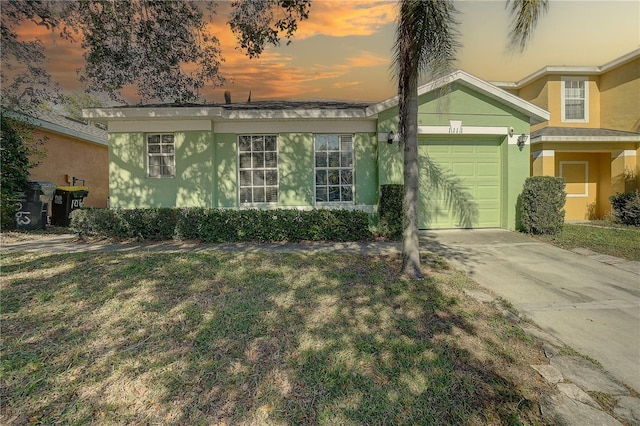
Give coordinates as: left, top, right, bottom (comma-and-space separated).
70, 208, 371, 243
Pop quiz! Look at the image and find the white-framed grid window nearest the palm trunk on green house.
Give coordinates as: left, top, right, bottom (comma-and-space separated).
314, 134, 353, 203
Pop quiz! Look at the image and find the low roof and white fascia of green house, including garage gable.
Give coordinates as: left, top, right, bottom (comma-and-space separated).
83, 71, 549, 124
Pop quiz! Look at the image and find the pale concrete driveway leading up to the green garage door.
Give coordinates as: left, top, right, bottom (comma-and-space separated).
420, 229, 640, 391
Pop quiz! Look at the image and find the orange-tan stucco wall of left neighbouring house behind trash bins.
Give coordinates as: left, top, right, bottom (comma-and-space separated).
30, 130, 109, 207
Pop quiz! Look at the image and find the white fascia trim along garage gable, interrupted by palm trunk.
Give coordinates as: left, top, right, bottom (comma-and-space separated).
367, 70, 550, 124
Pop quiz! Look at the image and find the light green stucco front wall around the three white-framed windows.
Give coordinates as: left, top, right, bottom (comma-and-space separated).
109, 131, 378, 208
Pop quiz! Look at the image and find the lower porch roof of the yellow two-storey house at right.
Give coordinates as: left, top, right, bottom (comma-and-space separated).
531, 127, 640, 143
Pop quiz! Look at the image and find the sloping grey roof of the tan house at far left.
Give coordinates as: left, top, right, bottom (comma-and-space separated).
4, 111, 108, 146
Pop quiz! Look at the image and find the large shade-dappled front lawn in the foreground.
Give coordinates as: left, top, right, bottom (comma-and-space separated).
0, 252, 548, 425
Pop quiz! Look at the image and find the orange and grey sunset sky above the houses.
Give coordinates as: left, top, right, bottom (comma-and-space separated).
8, 0, 640, 103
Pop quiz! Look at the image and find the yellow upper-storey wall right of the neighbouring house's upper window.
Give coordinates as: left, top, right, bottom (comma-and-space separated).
599, 58, 640, 133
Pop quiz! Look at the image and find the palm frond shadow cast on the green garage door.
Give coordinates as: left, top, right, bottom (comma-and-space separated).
419, 155, 478, 228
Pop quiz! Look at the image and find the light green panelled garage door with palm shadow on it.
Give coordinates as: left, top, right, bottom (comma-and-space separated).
418, 138, 501, 229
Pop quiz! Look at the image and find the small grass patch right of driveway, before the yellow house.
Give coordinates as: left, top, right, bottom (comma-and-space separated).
539, 222, 640, 261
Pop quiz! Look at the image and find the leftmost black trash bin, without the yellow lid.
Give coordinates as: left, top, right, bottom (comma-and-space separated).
14, 181, 56, 230
